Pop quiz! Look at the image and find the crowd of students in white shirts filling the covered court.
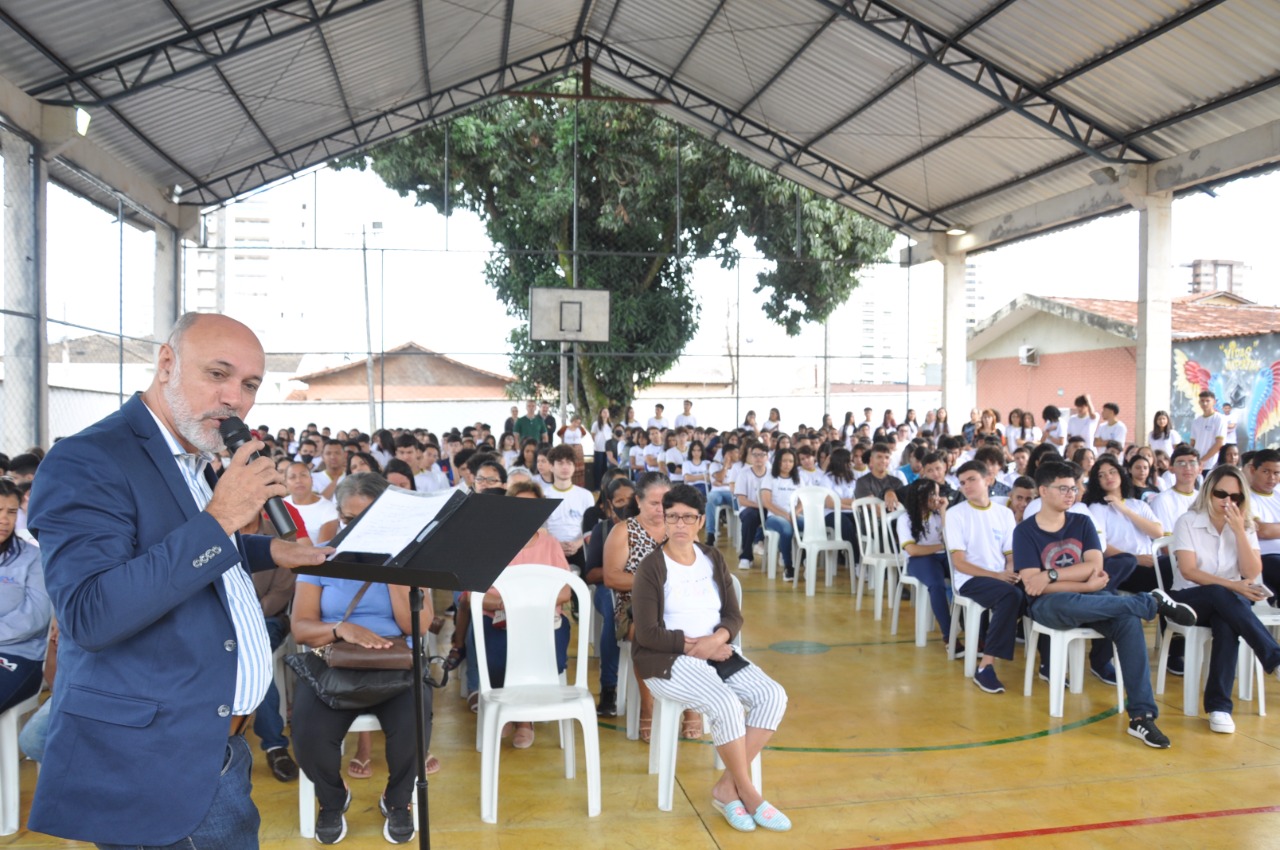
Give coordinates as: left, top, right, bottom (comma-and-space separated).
0, 392, 1280, 829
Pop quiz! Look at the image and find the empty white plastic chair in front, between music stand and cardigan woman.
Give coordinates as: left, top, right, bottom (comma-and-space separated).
471, 565, 600, 823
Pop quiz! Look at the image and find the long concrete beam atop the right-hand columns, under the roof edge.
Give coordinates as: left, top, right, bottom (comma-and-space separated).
901, 120, 1280, 265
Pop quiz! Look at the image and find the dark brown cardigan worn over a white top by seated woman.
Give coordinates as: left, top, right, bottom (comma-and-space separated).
631, 543, 742, 678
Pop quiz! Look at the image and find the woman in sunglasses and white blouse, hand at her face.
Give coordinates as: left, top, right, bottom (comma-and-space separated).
1169, 466, 1280, 734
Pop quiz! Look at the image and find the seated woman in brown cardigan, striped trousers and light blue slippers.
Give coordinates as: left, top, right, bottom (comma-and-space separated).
631, 484, 791, 832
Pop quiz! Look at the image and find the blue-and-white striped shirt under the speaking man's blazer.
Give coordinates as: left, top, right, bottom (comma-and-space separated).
147, 407, 273, 714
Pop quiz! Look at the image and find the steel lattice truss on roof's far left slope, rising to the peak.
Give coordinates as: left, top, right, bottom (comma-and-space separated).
182, 41, 585, 206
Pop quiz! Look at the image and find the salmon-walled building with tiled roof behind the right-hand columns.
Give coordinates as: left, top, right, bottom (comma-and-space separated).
952, 292, 1280, 445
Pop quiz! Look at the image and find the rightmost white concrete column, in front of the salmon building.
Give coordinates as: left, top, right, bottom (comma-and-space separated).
1136, 192, 1174, 443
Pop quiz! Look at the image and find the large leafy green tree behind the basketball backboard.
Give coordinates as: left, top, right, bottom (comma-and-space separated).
335, 78, 892, 417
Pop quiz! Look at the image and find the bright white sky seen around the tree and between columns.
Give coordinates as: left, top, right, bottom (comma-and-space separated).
22, 161, 1280, 381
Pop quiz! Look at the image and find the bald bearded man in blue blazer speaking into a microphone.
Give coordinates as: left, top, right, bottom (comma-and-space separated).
28, 314, 329, 850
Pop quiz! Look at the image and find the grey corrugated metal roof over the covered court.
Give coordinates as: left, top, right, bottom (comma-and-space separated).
0, 0, 1280, 245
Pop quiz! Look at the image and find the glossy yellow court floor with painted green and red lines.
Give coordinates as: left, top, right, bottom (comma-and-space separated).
0, 540, 1280, 850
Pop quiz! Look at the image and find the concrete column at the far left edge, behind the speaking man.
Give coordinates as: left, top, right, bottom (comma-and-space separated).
0, 128, 49, 454
